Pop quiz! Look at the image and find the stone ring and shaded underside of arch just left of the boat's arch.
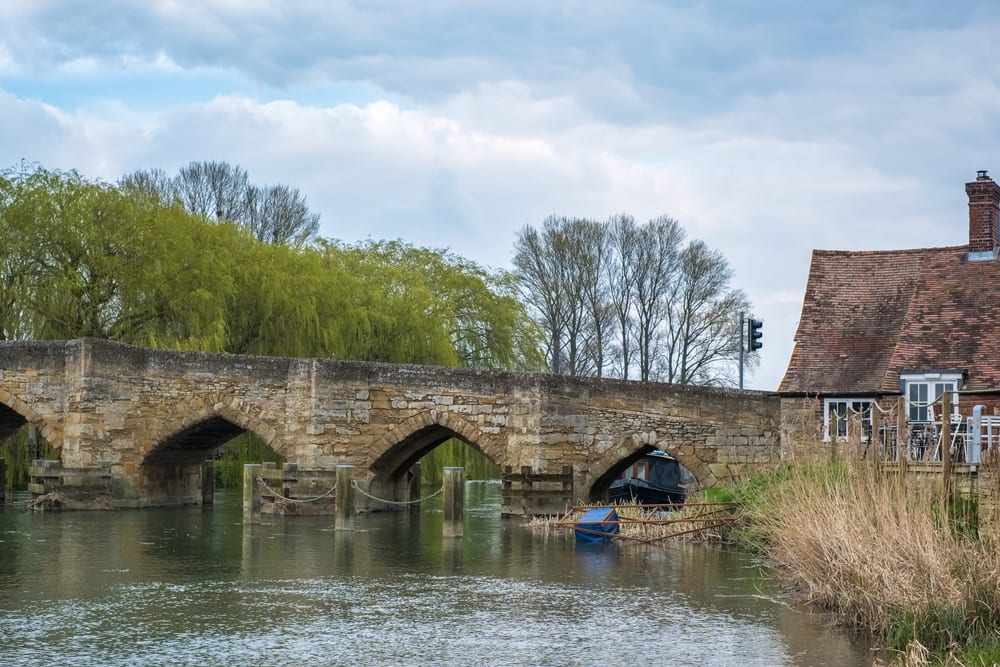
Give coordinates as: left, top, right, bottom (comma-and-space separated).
368, 410, 503, 509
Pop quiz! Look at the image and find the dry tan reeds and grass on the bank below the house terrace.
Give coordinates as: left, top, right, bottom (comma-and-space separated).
732, 460, 1000, 665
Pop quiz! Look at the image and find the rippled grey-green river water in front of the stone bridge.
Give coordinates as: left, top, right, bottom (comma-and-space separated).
0, 482, 872, 667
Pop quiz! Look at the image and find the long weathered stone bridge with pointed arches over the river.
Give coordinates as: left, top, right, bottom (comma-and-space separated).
0, 339, 780, 514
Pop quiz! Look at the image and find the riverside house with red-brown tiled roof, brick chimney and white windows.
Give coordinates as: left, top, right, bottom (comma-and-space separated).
778, 171, 1000, 460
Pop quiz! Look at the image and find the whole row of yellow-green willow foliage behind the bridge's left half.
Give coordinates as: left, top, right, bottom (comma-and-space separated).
0, 164, 544, 370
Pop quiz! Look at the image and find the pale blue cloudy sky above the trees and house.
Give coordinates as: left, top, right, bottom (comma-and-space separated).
0, 0, 1000, 390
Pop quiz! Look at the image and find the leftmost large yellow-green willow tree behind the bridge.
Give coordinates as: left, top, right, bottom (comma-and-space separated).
0, 167, 231, 349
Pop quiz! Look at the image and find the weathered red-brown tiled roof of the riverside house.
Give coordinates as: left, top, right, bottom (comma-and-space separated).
778, 246, 1000, 394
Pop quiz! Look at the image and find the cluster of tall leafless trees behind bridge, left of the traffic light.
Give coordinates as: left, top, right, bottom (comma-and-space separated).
514, 209, 756, 384
